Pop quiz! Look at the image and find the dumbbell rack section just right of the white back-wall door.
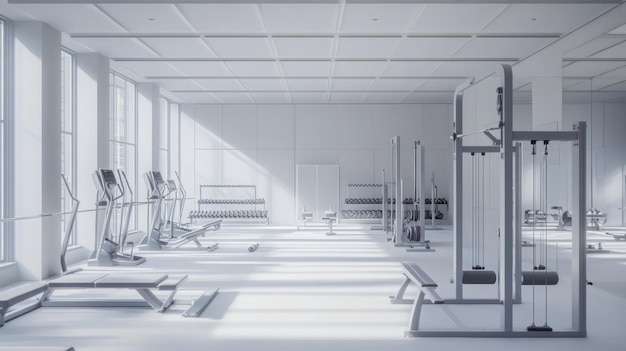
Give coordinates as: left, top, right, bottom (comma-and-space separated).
341, 184, 383, 223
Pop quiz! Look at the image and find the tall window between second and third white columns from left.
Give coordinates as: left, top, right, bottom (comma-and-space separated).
109, 73, 137, 229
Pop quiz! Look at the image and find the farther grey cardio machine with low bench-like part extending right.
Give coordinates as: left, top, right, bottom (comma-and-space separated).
140, 171, 222, 251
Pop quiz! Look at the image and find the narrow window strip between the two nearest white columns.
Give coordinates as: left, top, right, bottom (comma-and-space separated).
61, 50, 76, 245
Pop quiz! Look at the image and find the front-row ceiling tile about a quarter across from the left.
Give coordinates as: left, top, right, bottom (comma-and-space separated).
98, 4, 194, 33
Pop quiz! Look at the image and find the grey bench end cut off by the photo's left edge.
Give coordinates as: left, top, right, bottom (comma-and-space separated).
0, 282, 48, 327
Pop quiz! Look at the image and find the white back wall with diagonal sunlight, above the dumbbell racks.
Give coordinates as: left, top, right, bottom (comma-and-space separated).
181, 104, 452, 224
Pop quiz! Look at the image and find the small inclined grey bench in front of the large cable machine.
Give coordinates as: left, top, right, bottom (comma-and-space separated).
389, 262, 444, 336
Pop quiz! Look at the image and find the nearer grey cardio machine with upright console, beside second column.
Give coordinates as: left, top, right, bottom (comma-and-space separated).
87, 169, 146, 266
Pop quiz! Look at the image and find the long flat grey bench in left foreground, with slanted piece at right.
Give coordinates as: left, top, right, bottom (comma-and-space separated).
41, 273, 218, 317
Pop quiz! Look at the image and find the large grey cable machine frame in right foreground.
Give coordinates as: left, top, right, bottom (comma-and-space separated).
408, 65, 587, 337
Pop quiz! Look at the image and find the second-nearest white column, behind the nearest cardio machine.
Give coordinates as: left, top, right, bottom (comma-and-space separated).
74, 53, 111, 256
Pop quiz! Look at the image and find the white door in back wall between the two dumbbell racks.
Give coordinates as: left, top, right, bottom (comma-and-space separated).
296, 165, 339, 221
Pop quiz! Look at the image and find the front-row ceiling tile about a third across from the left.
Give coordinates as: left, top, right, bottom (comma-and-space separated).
178, 4, 264, 33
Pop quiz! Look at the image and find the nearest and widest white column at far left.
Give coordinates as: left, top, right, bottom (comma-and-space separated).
13, 21, 61, 279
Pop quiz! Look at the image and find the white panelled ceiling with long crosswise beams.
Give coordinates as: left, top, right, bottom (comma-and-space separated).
0, 0, 626, 103
